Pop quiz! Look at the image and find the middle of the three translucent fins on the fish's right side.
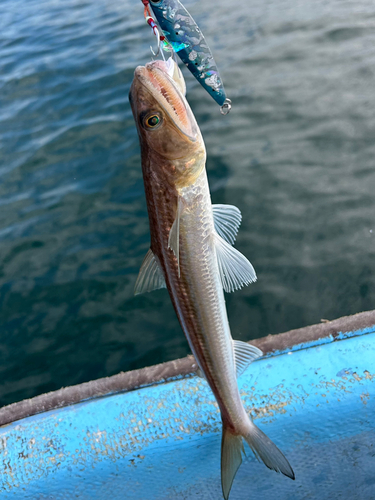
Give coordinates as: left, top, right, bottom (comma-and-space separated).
214, 233, 257, 292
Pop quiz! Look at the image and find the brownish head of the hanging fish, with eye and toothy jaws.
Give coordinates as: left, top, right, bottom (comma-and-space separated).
129, 58, 206, 185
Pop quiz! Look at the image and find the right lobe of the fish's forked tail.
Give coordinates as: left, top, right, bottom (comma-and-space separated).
244, 420, 295, 479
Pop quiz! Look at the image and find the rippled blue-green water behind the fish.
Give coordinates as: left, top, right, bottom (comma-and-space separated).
0, 0, 375, 406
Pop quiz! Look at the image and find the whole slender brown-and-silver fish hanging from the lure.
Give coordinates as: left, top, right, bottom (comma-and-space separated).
129, 59, 294, 500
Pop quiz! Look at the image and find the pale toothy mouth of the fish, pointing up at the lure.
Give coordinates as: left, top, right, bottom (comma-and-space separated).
134, 58, 199, 142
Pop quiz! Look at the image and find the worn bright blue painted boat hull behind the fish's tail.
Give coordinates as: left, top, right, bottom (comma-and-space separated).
0, 314, 375, 500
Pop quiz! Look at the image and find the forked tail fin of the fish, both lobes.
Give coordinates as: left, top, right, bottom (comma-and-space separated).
221, 422, 295, 500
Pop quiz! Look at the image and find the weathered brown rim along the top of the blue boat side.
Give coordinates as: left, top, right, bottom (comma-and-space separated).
0, 310, 375, 426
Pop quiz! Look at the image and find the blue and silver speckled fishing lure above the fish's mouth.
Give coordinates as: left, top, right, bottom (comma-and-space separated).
142, 0, 231, 115
